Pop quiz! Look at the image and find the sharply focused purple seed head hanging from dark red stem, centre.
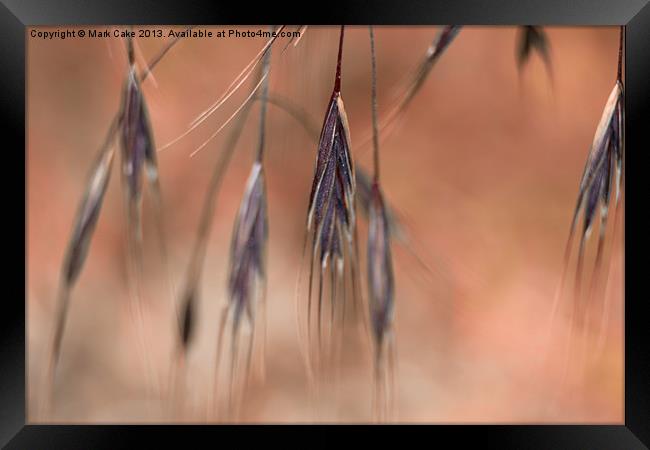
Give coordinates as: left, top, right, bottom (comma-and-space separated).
306, 26, 360, 358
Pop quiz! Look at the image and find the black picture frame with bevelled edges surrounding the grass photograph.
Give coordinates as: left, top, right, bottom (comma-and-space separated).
5, 0, 650, 449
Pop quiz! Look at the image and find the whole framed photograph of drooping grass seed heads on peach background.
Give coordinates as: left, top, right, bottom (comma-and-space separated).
26, 25, 625, 423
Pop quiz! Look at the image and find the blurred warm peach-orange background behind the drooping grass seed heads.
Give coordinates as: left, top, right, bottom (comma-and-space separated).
26, 27, 623, 423
